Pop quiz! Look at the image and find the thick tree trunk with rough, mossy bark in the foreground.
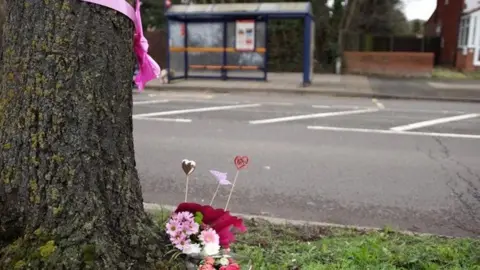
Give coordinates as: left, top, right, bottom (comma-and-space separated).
0, 0, 162, 270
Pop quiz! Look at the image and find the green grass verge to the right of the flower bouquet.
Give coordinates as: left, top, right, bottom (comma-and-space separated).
150, 211, 480, 270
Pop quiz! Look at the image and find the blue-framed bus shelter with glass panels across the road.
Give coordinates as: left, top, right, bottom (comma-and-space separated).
166, 2, 315, 86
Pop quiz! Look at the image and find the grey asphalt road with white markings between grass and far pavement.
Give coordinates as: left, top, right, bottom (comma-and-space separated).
133, 92, 480, 236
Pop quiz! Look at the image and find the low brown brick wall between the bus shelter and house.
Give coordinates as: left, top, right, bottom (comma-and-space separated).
344, 52, 434, 77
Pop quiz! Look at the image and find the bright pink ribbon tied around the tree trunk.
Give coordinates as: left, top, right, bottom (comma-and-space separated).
81, 0, 161, 90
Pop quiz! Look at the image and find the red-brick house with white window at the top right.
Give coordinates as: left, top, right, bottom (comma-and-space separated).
425, 0, 480, 71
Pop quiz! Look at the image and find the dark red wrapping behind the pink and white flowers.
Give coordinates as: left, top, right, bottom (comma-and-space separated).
175, 203, 247, 249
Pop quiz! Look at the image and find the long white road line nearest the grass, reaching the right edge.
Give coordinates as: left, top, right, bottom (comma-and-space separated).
307, 126, 480, 139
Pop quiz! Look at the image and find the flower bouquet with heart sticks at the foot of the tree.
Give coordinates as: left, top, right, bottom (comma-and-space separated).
166, 157, 248, 270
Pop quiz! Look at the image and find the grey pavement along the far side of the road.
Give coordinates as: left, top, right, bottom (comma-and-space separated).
147, 73, 480, 102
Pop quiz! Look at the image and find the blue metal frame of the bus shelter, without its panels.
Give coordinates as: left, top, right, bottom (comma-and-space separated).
165, 3, 313, 86
